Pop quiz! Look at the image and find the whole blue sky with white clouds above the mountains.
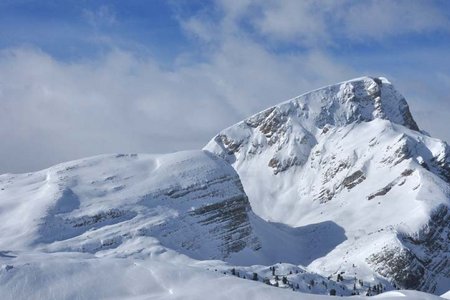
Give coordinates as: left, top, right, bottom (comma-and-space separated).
0, 0, 450, 173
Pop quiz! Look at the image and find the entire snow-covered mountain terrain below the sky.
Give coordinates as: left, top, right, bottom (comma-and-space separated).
0, 77, 450, 300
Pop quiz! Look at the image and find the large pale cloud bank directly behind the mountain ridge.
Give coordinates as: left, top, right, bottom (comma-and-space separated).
0, 39, 356, 172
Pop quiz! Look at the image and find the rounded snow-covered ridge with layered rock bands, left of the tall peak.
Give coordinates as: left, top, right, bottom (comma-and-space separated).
0, 151, 260, 259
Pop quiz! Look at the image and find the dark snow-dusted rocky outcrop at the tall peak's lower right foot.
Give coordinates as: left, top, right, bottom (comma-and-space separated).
368, 206, 450, 293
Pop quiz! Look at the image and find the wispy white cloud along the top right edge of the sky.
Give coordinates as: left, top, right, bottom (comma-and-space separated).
211, 0, 450, 47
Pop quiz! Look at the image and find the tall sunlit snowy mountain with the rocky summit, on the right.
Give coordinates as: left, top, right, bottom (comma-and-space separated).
205, 77, 450, 293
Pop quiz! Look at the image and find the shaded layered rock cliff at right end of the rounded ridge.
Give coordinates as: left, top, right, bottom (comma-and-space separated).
139, 176, 261, 259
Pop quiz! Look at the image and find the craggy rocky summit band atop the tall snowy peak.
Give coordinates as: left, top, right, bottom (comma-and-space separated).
206, 77, 419, 174
